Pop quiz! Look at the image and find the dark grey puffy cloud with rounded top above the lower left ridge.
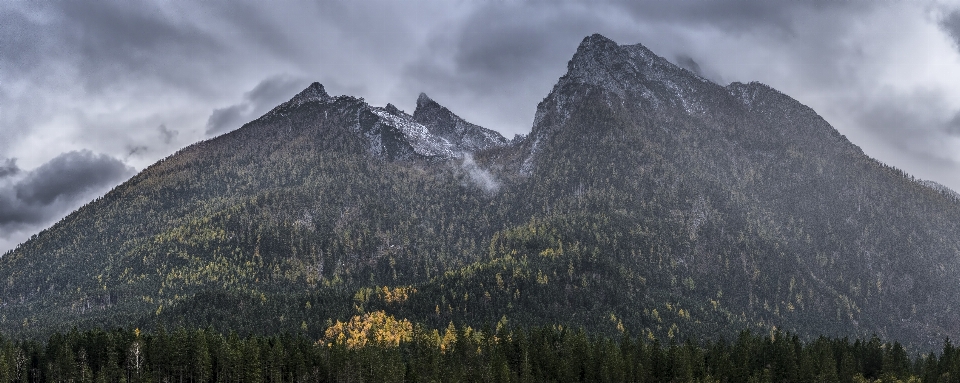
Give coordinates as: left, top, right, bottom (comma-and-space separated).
13, 150, 134, 205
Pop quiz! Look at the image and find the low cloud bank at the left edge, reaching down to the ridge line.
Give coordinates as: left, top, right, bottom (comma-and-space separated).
0, 150, 135, 254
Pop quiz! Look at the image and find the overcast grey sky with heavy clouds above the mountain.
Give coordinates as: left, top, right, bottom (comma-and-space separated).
0, 0, 960, 252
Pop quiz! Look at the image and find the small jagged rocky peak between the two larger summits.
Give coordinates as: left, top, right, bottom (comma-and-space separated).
413, 93, 507, 152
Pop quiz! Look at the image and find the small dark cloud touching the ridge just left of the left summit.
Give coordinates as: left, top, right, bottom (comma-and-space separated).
206, 76, 307, 135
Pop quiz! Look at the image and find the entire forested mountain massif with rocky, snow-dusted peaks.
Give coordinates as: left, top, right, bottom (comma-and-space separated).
0, 35, 960, 350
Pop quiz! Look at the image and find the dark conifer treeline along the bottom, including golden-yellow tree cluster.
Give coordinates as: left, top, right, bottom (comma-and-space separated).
0, 318, 960, 382
